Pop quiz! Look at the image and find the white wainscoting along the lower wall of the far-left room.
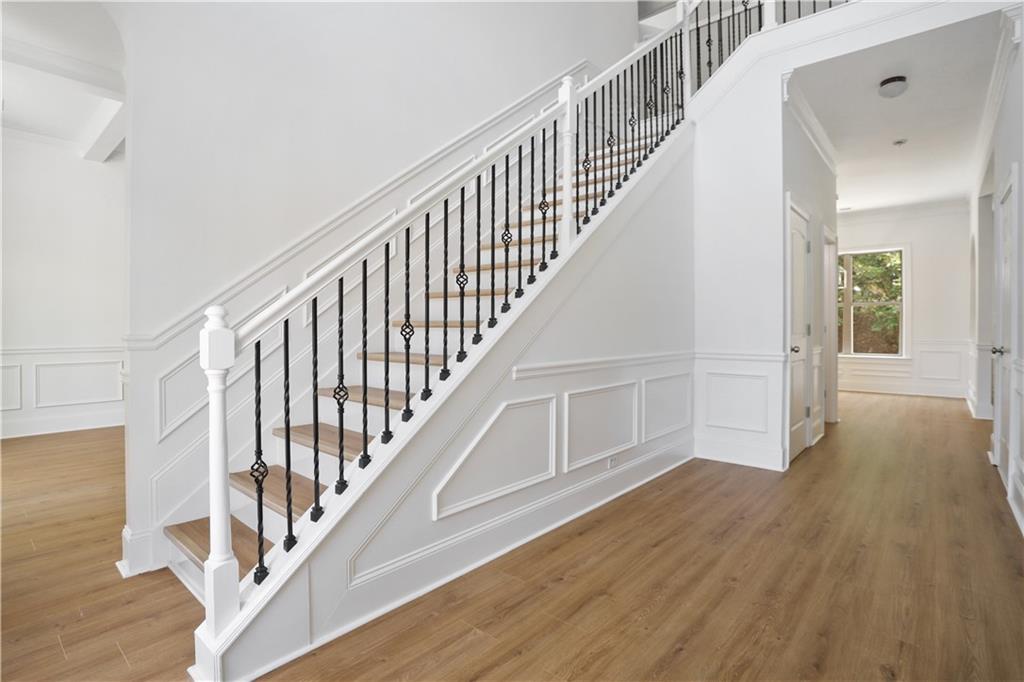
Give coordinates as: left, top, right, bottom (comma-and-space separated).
0, 346, 124, 438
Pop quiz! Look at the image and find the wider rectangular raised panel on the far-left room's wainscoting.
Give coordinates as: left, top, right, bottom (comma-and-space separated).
35, 360, 122, 408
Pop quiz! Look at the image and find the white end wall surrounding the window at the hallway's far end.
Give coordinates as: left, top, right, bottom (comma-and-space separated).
839, 200, 971, 397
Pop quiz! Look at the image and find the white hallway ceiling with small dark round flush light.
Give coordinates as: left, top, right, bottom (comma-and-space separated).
793, 12, 999, 210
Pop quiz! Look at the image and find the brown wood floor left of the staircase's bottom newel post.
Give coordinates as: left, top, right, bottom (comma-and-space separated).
0, 428, 203, 682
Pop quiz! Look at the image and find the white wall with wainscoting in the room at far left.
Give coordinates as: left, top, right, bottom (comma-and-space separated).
0, 130, 127, 437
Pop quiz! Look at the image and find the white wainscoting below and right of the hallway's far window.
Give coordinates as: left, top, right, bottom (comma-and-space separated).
839, 339, 971, 398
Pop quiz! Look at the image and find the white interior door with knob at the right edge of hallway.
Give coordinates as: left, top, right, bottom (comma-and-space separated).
992, 168, 1019, 486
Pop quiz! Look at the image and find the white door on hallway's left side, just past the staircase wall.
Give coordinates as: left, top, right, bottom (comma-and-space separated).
790, 205, 811, 456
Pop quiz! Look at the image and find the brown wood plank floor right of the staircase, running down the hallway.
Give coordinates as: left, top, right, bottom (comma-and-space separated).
267, 393, 1024, 680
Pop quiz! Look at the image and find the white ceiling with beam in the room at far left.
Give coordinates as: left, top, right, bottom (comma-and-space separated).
0, 2, 125, 155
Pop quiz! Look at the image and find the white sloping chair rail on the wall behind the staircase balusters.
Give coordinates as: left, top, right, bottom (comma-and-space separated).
124, 59, 591, 350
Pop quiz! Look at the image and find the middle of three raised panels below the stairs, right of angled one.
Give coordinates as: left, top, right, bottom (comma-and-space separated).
564, 381, 637, 471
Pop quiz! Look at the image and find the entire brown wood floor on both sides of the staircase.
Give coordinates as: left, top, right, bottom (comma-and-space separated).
0, 393, 1024, 680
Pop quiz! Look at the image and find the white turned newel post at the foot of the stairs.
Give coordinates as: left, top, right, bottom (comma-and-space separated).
199, 305, 239, 636
